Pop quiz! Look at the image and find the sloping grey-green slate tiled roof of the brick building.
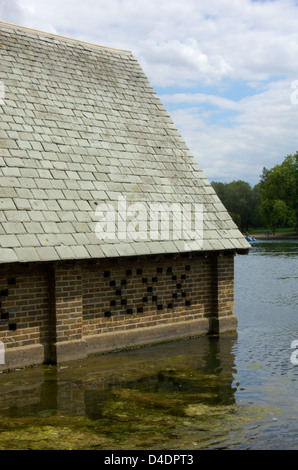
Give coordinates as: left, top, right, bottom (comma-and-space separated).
0, 22, 249, 263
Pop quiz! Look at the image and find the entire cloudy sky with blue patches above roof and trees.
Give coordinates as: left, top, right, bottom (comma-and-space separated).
0, 0, 298, 186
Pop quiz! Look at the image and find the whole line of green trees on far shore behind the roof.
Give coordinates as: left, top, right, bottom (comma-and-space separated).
211, 151, 298, 233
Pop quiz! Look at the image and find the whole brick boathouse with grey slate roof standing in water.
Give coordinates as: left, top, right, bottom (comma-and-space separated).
0, 22, 249, 369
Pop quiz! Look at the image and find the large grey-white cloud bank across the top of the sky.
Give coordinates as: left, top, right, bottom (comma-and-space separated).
1, 0, 298, 86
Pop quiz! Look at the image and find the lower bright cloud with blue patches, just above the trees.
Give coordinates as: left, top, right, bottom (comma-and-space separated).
161, 80, 298, 184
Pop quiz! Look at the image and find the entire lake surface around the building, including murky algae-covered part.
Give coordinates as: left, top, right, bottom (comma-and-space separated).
0, 240, 298, 450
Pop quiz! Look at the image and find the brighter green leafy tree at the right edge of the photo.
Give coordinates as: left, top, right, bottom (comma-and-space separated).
260, 152, 298, 231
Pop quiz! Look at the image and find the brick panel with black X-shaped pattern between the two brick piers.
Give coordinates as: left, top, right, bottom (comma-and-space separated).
83, 256, 211, 336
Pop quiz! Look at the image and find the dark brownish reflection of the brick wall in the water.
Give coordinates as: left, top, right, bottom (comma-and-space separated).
0, 336, 239, 419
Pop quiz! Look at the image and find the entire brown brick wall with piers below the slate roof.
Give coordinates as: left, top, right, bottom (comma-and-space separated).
0, 252, 237, 369
